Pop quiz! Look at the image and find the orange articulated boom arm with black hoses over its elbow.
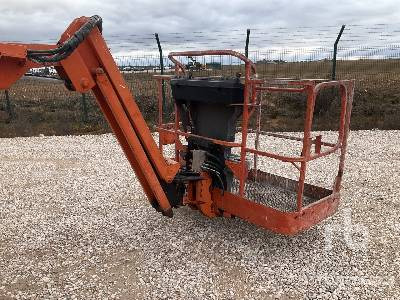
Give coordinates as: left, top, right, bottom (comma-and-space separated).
0, 16, 180, 216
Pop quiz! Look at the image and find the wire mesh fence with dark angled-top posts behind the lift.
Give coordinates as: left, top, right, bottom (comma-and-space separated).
0, 24, 400, 135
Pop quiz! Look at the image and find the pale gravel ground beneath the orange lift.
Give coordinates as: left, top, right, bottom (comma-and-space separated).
0, 130, 400, 299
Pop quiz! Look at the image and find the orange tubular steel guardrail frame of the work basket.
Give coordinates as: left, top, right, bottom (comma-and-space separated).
154, 50, 354, 235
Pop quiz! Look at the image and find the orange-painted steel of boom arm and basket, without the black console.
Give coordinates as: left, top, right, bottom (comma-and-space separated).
0, 17, 353, 234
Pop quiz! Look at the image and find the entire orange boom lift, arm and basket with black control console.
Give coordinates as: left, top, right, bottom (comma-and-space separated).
0, 16, 353, 235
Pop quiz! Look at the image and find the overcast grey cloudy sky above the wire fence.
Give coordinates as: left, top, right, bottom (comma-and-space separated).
0, 0, 400, 55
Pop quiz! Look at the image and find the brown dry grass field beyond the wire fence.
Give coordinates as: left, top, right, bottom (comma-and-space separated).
0, 59, 400, 137
